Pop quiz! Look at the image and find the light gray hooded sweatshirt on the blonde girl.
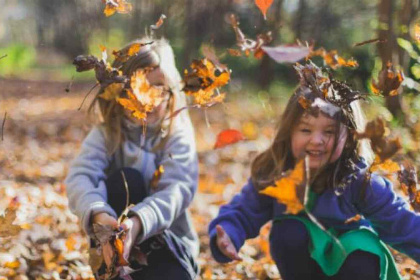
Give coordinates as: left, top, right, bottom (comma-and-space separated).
65, 112, 199, 257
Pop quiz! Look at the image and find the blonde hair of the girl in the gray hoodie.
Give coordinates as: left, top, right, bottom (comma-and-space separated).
89, 38, 188, 154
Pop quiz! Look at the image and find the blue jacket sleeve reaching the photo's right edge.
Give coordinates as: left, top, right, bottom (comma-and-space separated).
359, 174, 420, 263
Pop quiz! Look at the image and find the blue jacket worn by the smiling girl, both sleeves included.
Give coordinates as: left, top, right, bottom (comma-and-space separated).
209, 161, 420, 263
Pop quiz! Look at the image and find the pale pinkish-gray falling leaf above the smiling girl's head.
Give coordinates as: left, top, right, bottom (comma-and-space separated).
261, 45, 311, 63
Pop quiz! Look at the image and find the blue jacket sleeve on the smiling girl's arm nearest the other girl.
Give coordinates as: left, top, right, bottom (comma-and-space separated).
209, 180, 273, 263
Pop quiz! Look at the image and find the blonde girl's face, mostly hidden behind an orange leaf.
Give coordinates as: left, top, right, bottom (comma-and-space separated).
124, 67, 169, 125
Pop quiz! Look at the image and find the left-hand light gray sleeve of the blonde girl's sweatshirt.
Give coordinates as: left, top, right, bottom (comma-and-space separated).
65, 127, 117, 234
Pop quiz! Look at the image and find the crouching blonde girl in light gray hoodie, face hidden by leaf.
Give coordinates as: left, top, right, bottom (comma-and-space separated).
65, 40, 199, 279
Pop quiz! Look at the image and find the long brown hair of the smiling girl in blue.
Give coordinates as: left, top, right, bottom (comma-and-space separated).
251, 87, 372, 191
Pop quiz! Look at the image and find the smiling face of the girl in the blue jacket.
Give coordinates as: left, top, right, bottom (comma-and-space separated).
291, 113, 347, 171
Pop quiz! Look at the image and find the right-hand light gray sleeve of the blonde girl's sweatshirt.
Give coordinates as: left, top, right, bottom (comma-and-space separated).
130, 122, 198, 242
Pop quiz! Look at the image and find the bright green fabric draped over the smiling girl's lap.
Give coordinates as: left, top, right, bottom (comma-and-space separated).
274, 215, 402, 280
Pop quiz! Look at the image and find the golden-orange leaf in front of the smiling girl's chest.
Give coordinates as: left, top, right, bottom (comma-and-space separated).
260, 159, 305, 215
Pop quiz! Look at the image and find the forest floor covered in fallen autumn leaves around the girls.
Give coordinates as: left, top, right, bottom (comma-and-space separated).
0, 80, 420, 280
